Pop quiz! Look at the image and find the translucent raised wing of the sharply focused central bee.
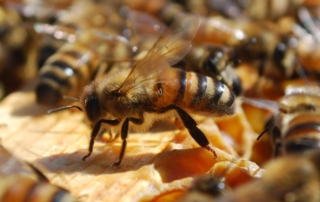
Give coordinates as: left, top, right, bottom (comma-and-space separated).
118, 15, 200, 92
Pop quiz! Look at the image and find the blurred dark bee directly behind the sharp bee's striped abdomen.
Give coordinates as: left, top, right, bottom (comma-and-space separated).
177, 45, 241, 95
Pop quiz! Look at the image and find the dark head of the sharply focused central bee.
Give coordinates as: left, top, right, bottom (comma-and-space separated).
80, 83, 101, 122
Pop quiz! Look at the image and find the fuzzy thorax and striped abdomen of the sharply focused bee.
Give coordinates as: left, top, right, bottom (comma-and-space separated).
84, 68, 235, 121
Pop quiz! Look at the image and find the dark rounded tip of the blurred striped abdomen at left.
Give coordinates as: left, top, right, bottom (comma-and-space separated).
36, 82, 62, 105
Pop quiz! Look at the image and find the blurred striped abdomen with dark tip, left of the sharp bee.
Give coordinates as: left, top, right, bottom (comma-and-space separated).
36, 43, 99, 105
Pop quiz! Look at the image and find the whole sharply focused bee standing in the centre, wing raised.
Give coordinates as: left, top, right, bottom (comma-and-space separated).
48, 15, 235, 166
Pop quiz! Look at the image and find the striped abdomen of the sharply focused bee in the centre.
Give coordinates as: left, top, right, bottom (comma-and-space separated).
156, 69, 235, 115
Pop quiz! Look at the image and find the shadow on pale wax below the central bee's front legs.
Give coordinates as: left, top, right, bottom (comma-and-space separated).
35, 149, 156, 175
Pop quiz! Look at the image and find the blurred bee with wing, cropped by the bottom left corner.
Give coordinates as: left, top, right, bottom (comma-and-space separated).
0, 145, 78, 202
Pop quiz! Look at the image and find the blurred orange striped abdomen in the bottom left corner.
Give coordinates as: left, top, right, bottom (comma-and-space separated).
0, 175, 77, 202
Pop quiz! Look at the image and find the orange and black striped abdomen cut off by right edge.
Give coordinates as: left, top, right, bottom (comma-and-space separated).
282, 113, 320, 153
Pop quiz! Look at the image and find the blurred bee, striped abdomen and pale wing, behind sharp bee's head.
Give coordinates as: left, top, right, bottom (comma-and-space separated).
36, 30, 132, 105
